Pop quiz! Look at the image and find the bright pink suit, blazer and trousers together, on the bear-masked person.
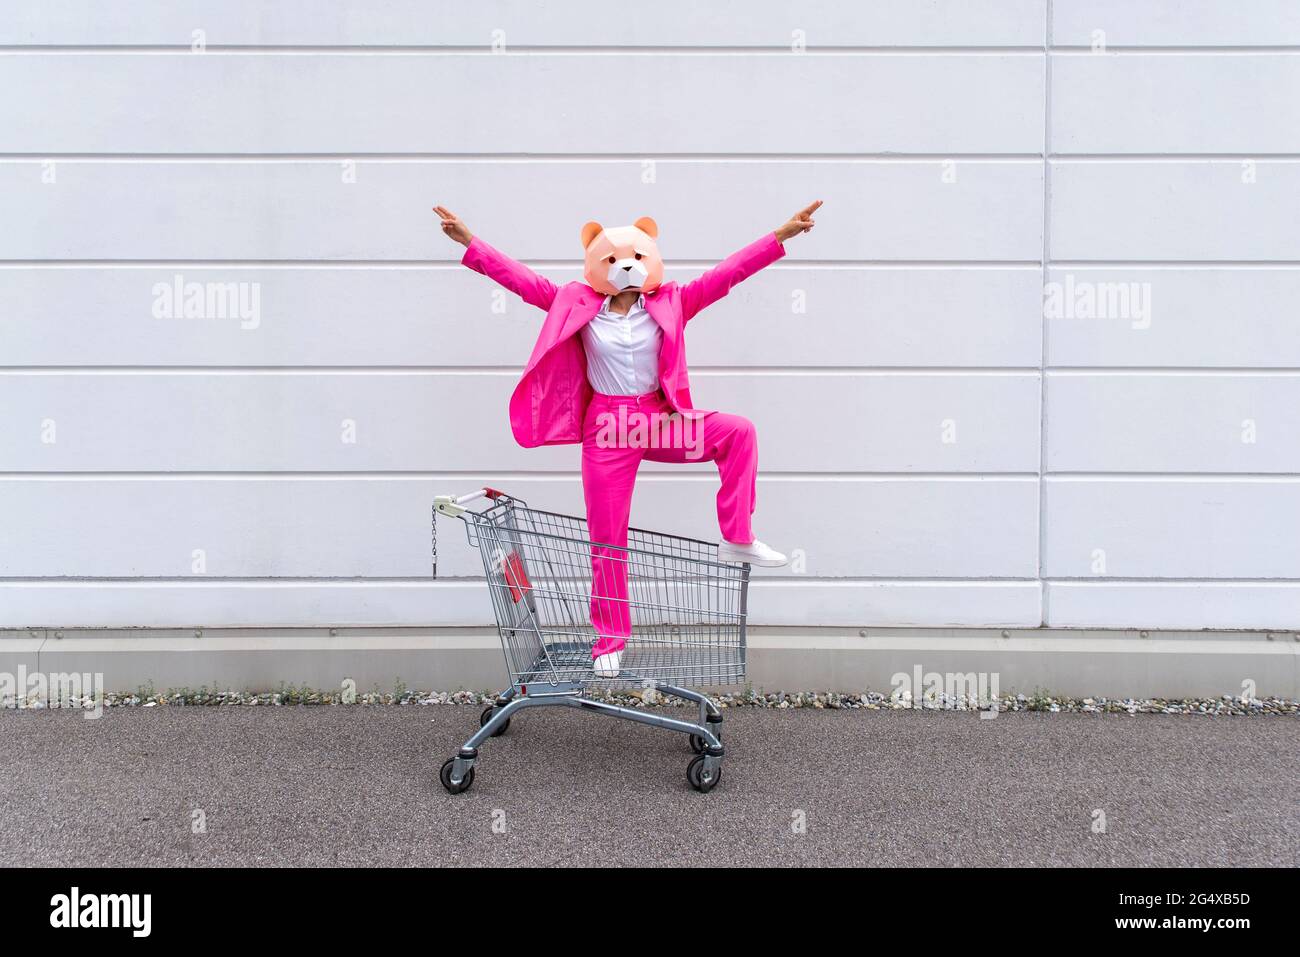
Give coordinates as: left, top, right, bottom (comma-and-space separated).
462, 233, 785, 657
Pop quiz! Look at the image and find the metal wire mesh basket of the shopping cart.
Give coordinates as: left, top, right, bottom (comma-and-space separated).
462, 499, 749, 687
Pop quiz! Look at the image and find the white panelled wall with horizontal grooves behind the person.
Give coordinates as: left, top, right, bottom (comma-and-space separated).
0, 0, 1300, 629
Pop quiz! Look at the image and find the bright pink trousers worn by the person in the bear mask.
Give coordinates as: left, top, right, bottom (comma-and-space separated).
582, 393, 758, 658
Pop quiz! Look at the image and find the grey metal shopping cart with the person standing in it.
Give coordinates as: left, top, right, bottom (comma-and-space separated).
433, 489, 750, 794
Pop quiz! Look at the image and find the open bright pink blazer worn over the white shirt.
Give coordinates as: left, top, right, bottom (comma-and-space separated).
460, 233, 785, 449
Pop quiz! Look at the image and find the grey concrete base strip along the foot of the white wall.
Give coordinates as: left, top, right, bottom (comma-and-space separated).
0, 628, 1300, 698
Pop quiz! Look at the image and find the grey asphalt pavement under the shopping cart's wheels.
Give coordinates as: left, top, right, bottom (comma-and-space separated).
0, 706, 1300, 867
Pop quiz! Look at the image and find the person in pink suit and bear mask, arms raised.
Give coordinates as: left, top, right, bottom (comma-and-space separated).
434, 200, 822, 677
